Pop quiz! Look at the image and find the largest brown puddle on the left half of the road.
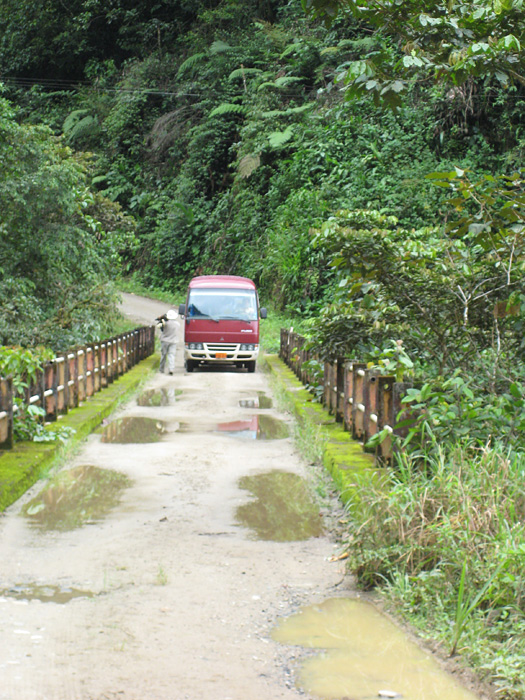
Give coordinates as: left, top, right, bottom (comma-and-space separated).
22, 466, 132, 532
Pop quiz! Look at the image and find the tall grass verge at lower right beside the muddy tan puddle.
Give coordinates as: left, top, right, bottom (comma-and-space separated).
347, 443, 525, 700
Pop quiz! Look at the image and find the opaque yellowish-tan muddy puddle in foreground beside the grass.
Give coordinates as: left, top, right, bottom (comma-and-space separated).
272, 598, 477, 700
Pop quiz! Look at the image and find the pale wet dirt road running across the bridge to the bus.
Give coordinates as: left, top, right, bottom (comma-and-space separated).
0, 296, 348, 700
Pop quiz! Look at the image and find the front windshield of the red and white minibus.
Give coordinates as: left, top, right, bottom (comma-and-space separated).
187, 288, 257, 321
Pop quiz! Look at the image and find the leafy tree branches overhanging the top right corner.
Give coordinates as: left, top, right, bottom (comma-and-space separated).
302, 0, 525, 107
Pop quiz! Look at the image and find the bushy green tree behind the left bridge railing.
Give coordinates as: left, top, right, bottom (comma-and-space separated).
0, 93, 137, 348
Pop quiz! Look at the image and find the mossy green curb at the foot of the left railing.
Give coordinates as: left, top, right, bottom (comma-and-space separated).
0, 354, 159, 512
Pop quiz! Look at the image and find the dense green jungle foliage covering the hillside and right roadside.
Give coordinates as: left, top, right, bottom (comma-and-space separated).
0, 0, 525, 698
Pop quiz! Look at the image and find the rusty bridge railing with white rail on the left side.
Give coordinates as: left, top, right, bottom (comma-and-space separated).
0, 326, 155, 450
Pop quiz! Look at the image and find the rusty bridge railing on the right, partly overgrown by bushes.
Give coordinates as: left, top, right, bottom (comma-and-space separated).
280, 328, 411, 462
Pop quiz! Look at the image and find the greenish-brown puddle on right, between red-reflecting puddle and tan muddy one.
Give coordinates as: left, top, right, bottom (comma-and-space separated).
235, 471, 323, 542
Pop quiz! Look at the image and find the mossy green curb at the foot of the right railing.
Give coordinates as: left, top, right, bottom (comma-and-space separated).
264, 355, 383, 503
